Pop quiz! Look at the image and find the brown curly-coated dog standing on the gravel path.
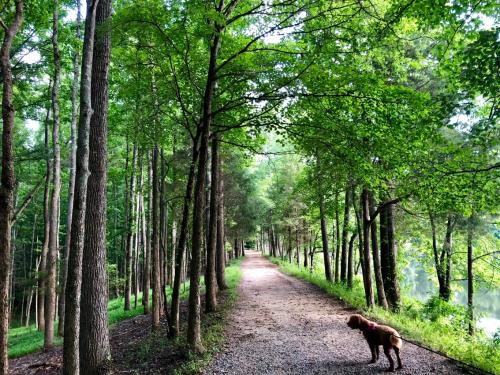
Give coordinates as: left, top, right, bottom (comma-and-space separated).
347, 314, 403, 371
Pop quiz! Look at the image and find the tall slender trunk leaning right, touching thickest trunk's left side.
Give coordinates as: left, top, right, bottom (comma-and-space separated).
63, 0, 102, 375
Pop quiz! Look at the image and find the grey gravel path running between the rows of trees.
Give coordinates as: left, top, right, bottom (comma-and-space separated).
205, 252, 476, 375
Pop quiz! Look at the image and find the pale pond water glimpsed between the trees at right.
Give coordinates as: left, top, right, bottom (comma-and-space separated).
401, 261, 500, 337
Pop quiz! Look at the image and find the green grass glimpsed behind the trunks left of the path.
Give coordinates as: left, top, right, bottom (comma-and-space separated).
9, 280, 199, 358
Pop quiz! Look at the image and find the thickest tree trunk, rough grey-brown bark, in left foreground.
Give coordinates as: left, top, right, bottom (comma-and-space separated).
80, 0, 111, 375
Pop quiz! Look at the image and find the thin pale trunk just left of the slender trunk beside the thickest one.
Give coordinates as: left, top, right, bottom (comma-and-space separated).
58, 1, 81, 336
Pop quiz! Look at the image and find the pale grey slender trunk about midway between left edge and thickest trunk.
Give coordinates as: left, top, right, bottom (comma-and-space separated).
43, 0, 61, 350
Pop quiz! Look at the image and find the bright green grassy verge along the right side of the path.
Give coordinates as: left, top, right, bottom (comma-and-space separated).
269, 258, 500, 374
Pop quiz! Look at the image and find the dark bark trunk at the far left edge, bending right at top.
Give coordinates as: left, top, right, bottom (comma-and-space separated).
0, 0, 24, 375
